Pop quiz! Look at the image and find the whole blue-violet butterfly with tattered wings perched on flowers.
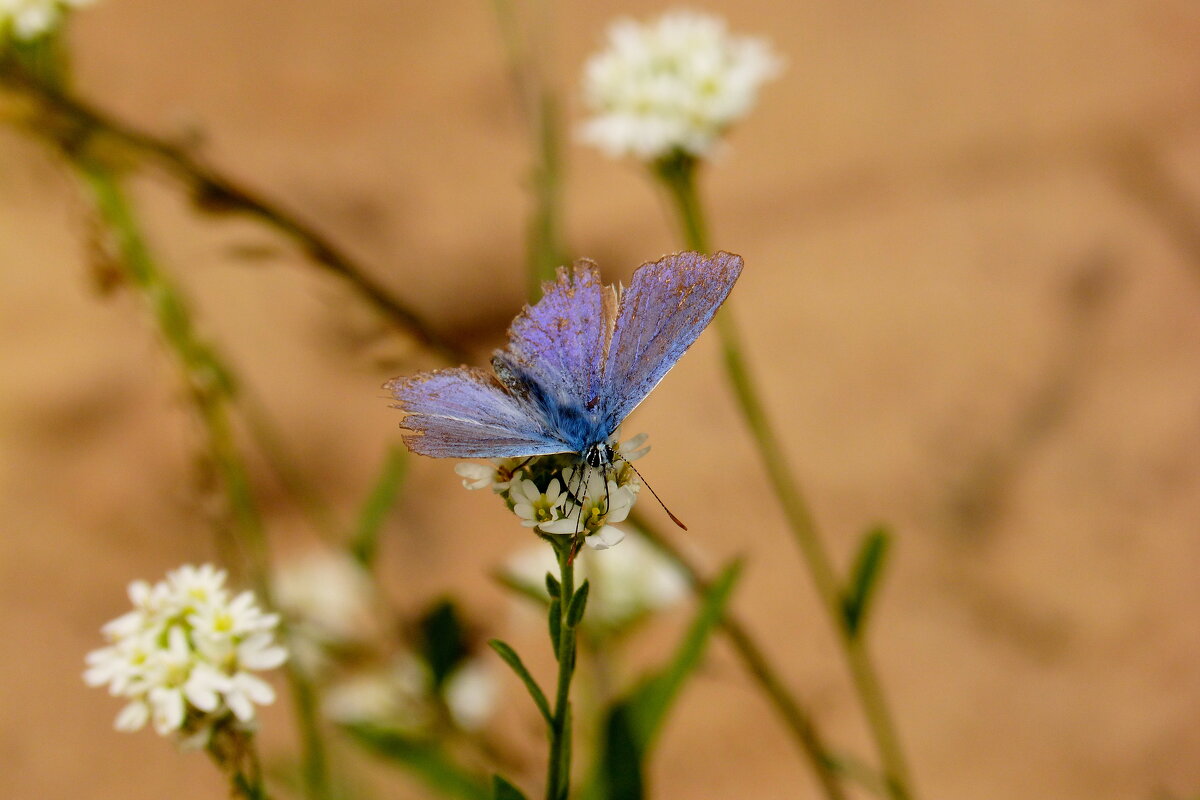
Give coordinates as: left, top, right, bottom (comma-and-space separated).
384, 252, 742, 524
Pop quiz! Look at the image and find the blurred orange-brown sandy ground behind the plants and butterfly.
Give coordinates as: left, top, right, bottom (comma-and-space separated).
0, 0, 1200, 800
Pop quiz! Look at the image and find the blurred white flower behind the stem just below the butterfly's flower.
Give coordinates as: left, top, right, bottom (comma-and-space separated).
505, 534, 688, 628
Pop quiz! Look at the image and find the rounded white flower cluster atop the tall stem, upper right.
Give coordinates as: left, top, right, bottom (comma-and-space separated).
581, 11, 782, 161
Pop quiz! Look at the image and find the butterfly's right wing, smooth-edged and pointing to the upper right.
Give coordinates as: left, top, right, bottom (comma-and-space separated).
604, 252, 742, 433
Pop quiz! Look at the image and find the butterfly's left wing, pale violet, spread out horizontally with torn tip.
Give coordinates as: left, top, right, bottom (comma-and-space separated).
384, 367, 570, 458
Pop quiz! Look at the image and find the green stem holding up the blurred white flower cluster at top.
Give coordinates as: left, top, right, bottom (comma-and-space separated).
655, 154, 916, 800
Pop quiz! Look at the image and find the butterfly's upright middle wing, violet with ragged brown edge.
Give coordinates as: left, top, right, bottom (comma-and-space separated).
492, 260, 617, 452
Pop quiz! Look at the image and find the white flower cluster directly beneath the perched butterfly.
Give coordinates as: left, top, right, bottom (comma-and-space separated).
455, 433, 649, 551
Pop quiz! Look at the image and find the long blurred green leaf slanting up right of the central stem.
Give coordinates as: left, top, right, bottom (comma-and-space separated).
589, 561, 742, 800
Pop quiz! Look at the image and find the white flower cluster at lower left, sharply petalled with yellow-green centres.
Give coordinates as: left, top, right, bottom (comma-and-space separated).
84, 564, 287, 736
